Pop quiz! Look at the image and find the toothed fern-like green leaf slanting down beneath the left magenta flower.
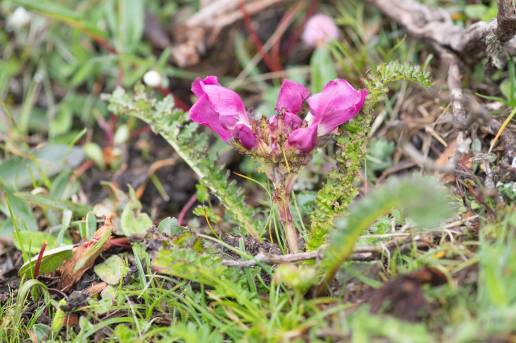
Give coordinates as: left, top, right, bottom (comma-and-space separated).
104, 86, 263, 240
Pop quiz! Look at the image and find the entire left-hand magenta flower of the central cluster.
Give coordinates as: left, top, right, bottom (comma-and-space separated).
189, 76, 256, 149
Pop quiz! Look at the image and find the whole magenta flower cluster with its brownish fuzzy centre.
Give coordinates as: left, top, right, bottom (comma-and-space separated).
190, 76, 367, 169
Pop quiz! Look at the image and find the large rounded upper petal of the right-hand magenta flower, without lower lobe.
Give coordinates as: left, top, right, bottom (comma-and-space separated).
307, 79, 367, 136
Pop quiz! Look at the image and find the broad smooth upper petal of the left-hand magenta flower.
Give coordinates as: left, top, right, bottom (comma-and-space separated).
202, 85, 249, 130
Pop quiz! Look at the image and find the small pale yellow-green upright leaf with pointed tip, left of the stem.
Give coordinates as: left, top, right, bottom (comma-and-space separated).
120, 188, 152, 237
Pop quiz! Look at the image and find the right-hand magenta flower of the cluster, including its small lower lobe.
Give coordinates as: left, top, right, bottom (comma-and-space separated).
288, 79, 367, 152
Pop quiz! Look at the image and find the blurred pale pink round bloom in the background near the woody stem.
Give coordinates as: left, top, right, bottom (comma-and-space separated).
303, 14, 339, 48
